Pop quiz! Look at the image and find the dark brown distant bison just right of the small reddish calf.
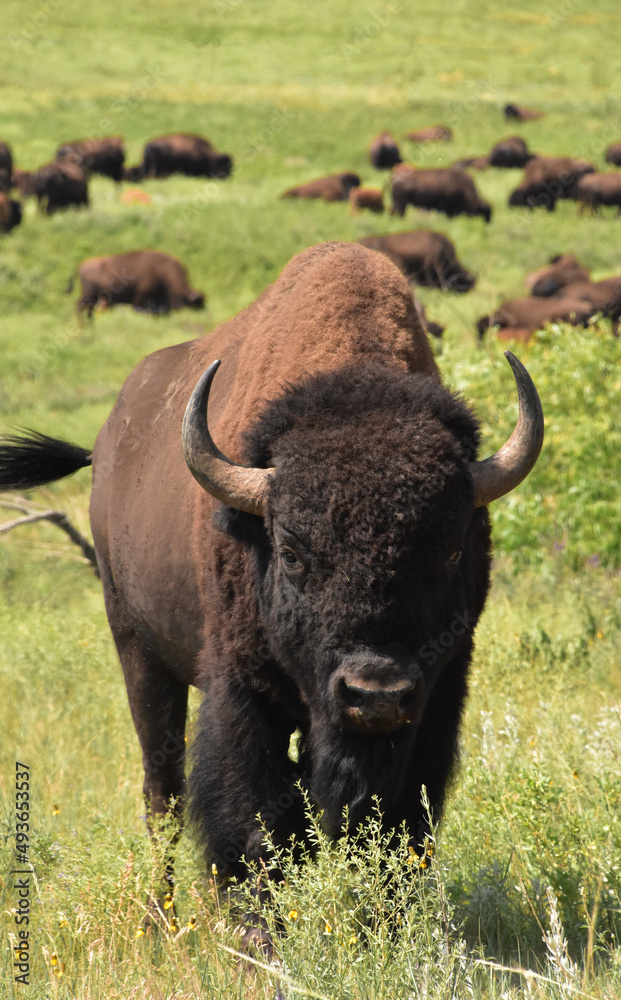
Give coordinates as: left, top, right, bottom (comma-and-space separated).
391, 164, 492, 222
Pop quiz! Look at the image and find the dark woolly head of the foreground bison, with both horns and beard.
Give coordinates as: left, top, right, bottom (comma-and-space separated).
183, 356, 542, 834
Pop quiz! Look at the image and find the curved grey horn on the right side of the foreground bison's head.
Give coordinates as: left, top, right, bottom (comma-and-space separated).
471, 351, 543, 507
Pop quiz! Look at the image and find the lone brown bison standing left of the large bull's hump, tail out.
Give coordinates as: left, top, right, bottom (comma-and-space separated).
72, 250, 205, 319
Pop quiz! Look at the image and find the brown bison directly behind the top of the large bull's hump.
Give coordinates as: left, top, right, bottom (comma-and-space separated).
360, 229, 476, 292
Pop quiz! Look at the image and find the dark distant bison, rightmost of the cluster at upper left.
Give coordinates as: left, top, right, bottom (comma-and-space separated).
123, 132, 233, 181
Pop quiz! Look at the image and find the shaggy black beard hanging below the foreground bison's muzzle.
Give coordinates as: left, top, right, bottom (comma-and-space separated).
309, 718, 420, 838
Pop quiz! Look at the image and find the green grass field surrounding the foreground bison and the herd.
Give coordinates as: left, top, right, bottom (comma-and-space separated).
0, 0, 621, 1000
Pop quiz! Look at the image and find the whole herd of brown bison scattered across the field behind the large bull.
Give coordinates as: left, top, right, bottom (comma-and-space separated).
0, 104, 621, 340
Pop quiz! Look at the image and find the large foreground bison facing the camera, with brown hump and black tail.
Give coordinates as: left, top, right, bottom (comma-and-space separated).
0, 243, 543, 937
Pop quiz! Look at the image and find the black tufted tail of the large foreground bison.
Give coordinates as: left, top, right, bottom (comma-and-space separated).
0, 431, 91, 491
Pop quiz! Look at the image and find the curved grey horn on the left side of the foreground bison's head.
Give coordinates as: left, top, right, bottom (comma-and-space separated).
181, 361, 274, 517
